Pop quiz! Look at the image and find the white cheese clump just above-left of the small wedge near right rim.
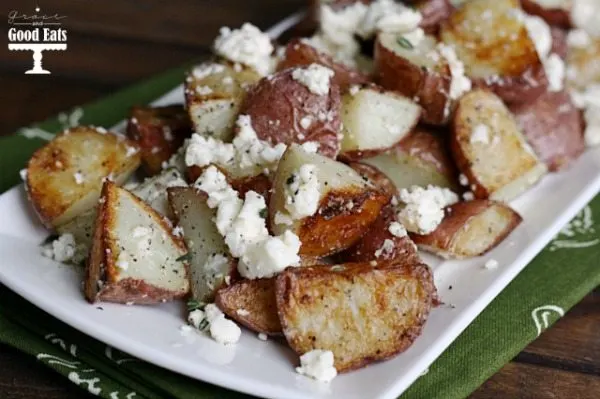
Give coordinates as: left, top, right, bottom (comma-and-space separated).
398, 185, 458, 234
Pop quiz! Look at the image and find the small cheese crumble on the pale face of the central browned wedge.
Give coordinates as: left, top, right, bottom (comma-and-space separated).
285, 164, 321, 219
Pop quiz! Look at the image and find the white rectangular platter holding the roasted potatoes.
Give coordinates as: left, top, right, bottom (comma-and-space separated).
0, 12, 600, 399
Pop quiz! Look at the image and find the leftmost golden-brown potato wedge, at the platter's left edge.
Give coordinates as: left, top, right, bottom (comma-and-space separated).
26, 126, 140, 228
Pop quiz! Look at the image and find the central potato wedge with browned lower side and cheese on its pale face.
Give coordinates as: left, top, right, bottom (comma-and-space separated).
269, 145, 389, 256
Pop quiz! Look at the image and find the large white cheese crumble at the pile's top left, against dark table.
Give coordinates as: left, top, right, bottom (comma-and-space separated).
214, 23, 273, 75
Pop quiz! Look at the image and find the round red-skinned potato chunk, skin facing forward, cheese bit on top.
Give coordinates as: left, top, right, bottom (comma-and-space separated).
241, 69, 341, 158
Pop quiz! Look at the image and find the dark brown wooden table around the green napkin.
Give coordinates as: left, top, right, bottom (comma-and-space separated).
0, 0, 600, 399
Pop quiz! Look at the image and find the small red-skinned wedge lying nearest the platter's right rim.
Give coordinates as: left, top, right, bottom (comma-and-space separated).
411, 200, 522, 259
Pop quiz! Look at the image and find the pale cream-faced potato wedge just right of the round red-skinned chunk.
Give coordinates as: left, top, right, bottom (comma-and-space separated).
339, 86, 421, 161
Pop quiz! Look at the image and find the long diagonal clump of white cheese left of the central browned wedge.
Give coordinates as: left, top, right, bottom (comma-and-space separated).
194, 166, 300, 279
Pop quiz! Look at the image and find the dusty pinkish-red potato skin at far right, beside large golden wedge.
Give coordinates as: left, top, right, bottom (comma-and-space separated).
511, 91, 585, 171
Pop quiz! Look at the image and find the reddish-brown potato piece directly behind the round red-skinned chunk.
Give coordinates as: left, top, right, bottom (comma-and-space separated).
277, 39, 369, 92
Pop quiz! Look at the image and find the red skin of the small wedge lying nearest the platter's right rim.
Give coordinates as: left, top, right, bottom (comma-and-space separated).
410, 199, 523, 255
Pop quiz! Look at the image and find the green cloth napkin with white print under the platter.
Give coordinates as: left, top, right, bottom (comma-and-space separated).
0, 67, 600, 399
